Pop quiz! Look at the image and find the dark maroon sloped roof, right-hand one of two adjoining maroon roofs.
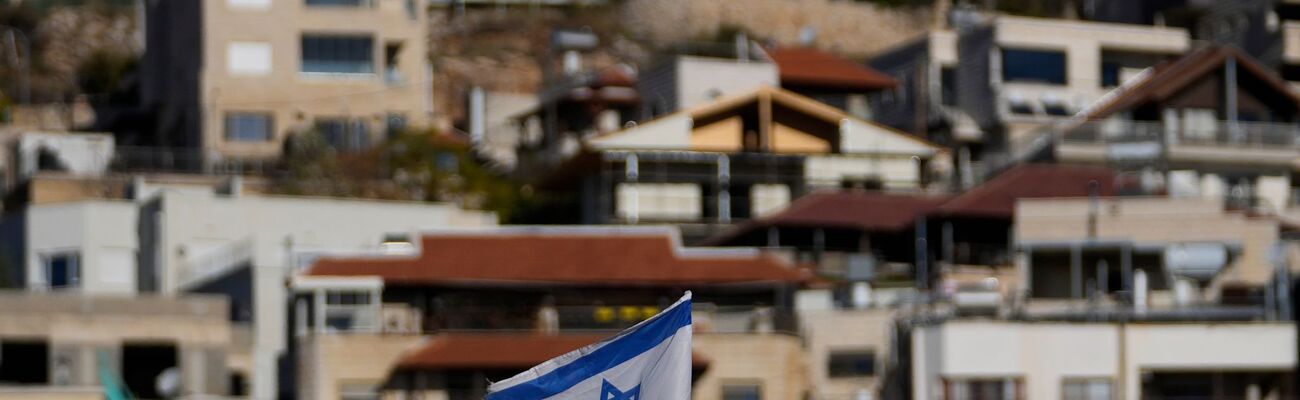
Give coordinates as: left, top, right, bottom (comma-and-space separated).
939, 164, 1114, 218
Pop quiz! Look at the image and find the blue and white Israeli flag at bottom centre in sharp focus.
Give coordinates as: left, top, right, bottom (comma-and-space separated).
488, 291, 690, 400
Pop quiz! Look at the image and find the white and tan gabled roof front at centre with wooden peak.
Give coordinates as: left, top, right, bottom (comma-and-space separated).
586, 86, 943, 156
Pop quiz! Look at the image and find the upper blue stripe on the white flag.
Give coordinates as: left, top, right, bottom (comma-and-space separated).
486, 300, 690, 400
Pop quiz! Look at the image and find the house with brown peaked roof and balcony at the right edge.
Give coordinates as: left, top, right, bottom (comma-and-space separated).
1034, 47, 1300, 213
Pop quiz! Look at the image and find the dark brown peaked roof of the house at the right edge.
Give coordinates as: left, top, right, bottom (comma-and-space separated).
1078, 45, 1300, 119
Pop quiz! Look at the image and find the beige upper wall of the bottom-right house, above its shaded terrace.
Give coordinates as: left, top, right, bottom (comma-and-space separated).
1015, 197, 1279, 284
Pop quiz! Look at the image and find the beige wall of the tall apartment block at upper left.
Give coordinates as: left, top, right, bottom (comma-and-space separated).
200, 0, 432, 157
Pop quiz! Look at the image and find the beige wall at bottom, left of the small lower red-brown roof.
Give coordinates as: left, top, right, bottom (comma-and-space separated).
298, 334, 428, 399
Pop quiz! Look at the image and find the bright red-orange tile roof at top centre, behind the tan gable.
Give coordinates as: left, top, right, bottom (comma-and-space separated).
767, 47, 897, 91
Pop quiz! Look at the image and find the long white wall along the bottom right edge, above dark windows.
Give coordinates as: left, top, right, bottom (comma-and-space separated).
913, 321, 1296, 399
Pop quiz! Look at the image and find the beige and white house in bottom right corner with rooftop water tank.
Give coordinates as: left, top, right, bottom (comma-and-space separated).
910, 197, 1296, 399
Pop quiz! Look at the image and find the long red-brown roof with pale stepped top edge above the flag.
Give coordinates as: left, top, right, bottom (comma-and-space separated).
308, 227, 805, 286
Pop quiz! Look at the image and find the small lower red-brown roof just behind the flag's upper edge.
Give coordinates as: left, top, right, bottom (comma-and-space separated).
397, 334, 709, 370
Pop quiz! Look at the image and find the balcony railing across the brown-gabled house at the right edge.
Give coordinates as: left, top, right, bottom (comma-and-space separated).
1060, 121, 1300, 148
